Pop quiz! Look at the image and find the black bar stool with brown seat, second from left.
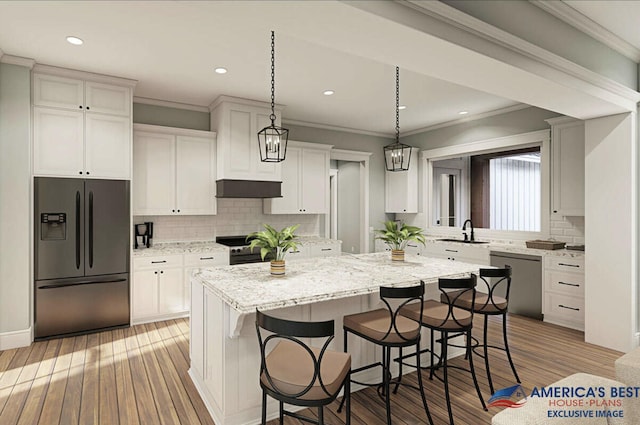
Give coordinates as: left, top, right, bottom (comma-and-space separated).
338, 282, 433, 425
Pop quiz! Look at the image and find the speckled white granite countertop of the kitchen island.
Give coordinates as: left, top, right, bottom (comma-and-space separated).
192, 252, 481, 314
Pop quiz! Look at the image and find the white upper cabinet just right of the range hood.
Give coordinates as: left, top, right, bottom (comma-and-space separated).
264, 141, 332, 214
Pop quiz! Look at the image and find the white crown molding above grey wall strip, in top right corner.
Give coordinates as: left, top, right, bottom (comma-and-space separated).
529, 0, 640, 62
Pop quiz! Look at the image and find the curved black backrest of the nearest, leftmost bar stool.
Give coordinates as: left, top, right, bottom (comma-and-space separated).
256, 310, 334, 399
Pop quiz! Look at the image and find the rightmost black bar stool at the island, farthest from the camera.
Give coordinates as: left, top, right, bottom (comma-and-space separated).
444, 266, 520, 394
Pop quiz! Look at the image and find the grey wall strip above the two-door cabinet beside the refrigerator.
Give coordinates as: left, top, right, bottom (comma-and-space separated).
133, 103, 210, 131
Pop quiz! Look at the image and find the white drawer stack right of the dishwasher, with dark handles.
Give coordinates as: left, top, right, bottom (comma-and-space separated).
542, 256, 584, 331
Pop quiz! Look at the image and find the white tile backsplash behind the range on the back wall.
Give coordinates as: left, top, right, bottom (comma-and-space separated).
133, 199, 320, 242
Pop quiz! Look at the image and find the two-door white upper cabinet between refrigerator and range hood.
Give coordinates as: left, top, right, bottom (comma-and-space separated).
132, 124, 216, 215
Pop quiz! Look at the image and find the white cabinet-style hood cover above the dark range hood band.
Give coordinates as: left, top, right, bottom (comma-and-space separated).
209, 96, 281, 181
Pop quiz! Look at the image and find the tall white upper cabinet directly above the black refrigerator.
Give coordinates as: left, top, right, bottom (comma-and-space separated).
33, 66, 135, 179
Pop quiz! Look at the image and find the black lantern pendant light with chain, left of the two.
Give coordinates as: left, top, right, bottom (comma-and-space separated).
258, 31, 289, 162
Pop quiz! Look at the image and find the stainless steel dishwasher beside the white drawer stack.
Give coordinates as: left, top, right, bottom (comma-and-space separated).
490, 251, 542, 320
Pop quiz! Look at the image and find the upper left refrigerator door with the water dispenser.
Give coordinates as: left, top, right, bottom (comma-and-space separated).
34, 177, 84, 280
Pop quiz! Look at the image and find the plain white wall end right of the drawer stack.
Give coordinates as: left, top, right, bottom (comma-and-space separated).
585, 113, 638, 352
